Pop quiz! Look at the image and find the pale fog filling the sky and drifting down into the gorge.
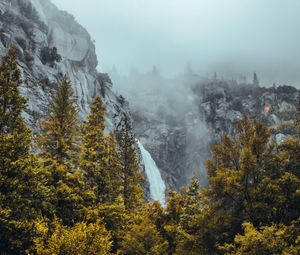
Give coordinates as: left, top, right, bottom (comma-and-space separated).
52, 0, 300, 187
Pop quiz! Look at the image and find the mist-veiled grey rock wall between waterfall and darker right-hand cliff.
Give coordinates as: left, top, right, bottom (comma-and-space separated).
112, 72, 212, 190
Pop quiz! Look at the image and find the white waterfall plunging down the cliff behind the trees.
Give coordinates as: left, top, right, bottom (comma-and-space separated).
138, 141, 166, 206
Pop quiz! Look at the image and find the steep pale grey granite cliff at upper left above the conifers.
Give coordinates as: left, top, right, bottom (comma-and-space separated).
0, 0, 129, 130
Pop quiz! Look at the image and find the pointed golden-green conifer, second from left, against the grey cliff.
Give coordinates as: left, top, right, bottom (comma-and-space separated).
38, 76, 78, 163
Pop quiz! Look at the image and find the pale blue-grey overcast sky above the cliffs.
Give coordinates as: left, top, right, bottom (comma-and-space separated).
52, 0, 300, 85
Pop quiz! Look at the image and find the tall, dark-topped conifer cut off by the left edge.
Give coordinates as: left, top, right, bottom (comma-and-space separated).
0, 47, 47, 254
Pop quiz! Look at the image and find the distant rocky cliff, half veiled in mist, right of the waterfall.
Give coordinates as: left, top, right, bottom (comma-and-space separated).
114, 70, 298, 189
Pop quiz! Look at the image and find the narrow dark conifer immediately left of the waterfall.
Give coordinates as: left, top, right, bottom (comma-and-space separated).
117, 118, 144, 211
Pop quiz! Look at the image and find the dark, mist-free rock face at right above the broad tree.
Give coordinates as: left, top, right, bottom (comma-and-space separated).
193, 81, 299, 143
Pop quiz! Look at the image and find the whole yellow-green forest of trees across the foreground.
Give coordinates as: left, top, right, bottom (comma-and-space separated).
0, 47, 300, 255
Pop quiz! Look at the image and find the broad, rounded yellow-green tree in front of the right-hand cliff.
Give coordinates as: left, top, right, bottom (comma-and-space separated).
202, 118, 300, 251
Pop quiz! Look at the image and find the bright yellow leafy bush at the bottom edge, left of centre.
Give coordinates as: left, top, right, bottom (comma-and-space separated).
34, 219, 112, 255
